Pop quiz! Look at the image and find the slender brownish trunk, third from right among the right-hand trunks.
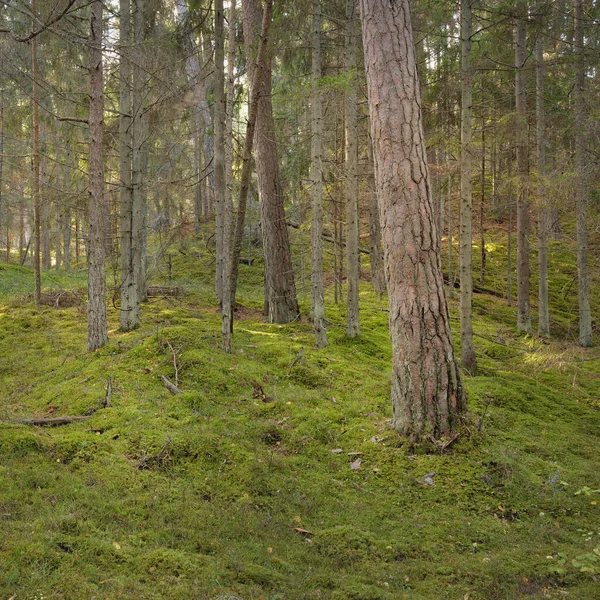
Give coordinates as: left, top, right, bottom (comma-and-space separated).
515, 0, 531, 333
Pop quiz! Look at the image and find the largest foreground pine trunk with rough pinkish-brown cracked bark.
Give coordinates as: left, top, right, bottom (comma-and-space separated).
360, 0, 466, 437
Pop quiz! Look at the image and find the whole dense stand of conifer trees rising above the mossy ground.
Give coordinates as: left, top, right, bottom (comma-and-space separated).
0, 0, 600, 434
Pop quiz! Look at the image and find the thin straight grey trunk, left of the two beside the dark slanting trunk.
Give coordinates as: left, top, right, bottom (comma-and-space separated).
214, 0, 225, 304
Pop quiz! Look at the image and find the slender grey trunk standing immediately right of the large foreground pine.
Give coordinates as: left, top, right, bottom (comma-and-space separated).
459, 0, 477, 375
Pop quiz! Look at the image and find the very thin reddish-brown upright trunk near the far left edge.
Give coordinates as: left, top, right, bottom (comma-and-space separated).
31, 0, 42, 307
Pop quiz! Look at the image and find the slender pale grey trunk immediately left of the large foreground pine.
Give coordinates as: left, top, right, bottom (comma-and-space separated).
345, 0, 360, 338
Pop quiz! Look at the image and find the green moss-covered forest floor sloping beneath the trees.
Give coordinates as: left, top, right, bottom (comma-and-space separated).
0, 227, 600, 600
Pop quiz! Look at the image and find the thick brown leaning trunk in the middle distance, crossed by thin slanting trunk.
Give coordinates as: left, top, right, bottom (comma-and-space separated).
242, 0, 300, 323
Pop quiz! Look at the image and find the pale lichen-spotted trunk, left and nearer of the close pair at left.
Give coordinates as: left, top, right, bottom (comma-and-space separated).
119, 0, 140, 331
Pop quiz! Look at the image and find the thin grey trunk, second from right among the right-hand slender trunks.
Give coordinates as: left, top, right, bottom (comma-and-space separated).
535, 32, 550, 337
